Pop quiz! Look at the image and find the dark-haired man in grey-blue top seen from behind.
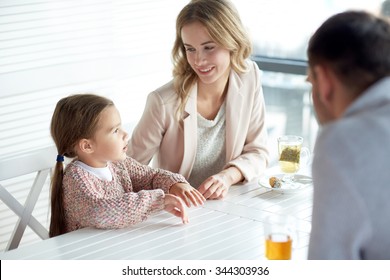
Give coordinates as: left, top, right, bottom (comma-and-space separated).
307, 11, 390, 259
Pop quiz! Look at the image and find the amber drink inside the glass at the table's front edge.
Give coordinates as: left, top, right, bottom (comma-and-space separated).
265, 233, 292, 260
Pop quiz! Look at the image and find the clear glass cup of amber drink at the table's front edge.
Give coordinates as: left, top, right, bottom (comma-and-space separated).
264, 215, 298, 260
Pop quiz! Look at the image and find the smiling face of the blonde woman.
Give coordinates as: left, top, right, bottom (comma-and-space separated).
181, 21, 230, 84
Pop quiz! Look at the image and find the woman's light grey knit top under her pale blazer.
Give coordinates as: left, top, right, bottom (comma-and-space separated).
188, 103, 226, 188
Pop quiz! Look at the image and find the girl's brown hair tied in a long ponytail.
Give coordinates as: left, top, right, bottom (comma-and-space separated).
49, 94, 114, 237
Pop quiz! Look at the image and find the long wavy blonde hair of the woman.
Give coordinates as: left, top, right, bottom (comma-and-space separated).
172, 0, 252, 117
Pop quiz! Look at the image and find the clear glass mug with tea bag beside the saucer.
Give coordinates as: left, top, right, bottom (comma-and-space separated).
278, 135, 310, 183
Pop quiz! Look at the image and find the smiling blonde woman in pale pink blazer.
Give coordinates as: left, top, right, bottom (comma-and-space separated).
128, 0, 268, 199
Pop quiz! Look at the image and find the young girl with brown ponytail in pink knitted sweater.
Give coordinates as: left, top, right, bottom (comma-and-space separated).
49, 94, 204, 237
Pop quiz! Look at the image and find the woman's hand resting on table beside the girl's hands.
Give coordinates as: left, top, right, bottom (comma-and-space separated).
199, 174, 230, 199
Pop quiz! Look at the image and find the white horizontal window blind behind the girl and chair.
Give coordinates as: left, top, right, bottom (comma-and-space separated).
0, 0, 188, 250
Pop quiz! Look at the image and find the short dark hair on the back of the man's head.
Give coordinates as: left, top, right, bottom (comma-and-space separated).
307, 11, 390, 95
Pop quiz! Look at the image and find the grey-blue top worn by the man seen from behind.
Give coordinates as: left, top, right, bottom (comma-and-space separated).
309, 78, 390, 260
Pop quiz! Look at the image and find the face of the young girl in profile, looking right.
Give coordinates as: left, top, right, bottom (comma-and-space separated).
90, 106, 128, 167
